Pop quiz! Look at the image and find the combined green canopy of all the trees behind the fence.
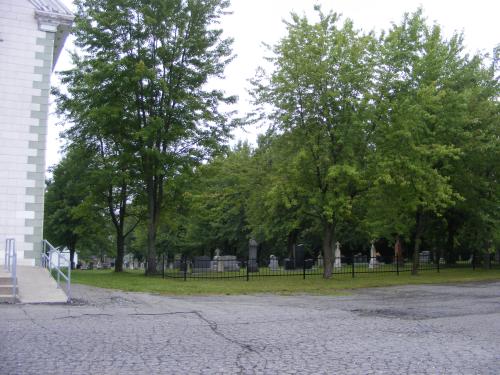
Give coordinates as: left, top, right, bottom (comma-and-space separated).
47, 4, 500, 277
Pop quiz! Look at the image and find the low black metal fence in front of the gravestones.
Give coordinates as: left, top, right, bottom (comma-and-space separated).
158, 254, 488, 280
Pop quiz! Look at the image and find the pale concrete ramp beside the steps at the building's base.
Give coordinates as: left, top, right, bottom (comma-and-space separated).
17, 266, 68, 303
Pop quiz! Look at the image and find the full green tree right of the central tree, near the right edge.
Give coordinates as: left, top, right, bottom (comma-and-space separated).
368, 10, 498, 273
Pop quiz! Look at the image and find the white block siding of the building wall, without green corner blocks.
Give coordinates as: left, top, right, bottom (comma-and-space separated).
0, 0, 48, 265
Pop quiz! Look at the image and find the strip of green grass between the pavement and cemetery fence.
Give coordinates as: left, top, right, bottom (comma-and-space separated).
71, 268, 500, 295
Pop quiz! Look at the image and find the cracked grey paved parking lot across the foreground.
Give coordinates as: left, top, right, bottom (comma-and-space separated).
0, 282, 500, 375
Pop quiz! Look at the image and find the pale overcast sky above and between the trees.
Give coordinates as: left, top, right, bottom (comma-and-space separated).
47, 0, 500, 166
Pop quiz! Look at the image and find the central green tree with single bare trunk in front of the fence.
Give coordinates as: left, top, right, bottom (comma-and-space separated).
255, 11, 376, 278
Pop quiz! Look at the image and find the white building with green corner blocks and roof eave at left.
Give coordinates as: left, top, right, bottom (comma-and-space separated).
0, 0, 73, 266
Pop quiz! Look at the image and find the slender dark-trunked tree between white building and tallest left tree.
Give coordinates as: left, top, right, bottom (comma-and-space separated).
54, 75, 141, 272
